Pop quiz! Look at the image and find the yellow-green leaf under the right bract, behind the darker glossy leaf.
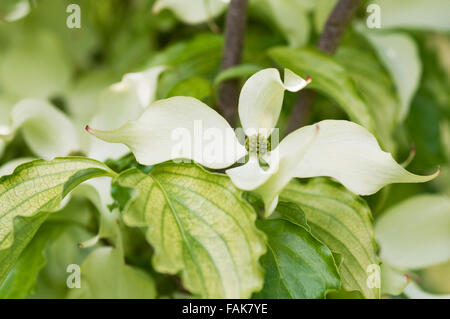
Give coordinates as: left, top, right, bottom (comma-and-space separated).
280, 178, 380, 298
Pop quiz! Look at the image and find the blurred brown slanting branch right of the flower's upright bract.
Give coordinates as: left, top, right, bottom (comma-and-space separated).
286, 0, 361, 133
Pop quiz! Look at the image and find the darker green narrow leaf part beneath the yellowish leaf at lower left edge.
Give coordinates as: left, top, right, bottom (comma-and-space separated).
0, 224, 64, 299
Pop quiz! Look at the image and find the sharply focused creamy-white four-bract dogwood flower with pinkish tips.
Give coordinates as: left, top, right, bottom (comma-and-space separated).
87, 69, 439, 213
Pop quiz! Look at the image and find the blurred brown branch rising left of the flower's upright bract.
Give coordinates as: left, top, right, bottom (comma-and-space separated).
217, 0, 248, 126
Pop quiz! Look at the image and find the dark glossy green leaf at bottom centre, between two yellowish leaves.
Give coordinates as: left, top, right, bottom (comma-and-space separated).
255, 219, 340, 299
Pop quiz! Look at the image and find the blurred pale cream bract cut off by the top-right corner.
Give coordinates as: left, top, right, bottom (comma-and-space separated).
373, 0, 450, 31
